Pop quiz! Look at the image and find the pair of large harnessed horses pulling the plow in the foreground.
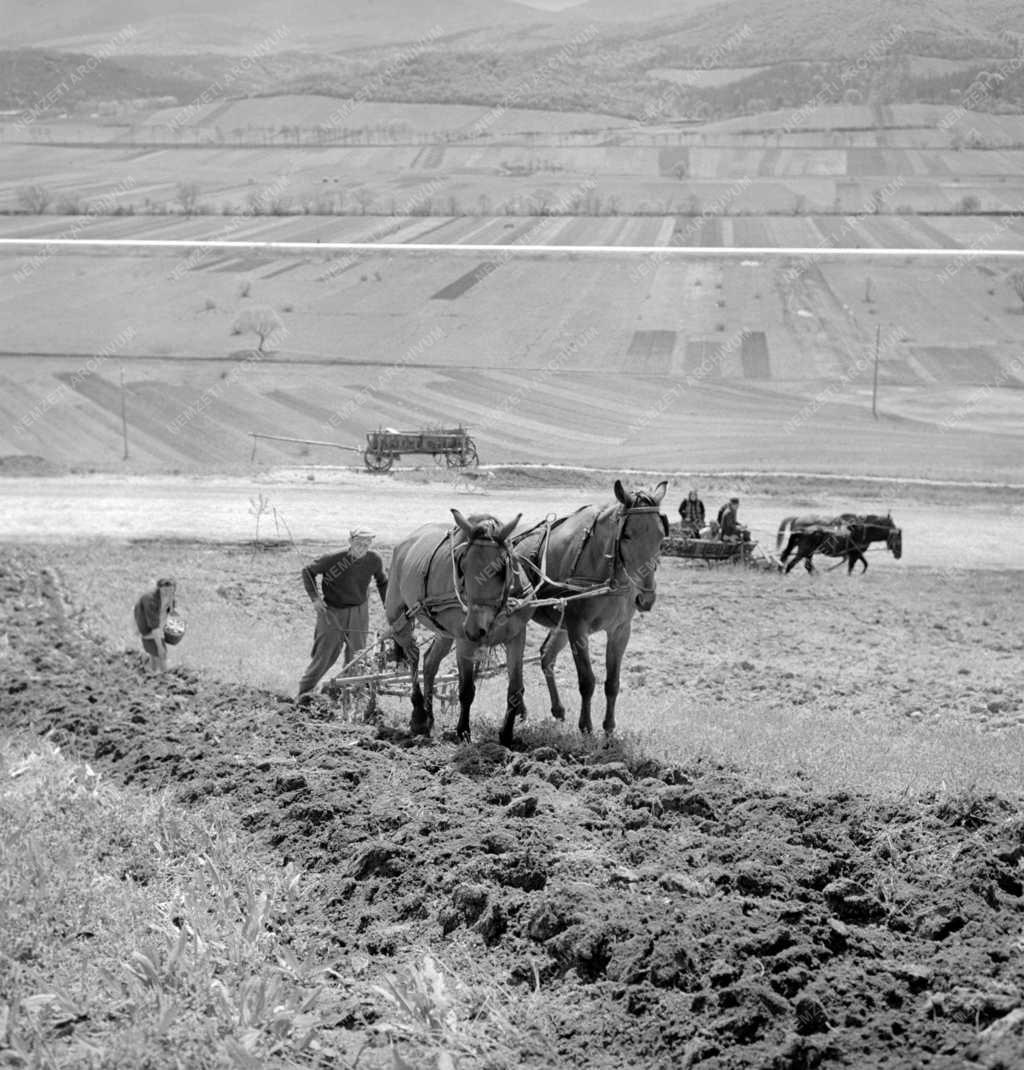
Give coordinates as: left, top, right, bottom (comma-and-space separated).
384, 480, 669, 747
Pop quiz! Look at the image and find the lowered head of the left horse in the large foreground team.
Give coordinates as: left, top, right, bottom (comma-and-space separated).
452, 509, 522, 643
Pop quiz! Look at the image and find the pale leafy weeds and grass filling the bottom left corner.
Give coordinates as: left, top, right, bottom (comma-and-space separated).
0, 740, 355, 1068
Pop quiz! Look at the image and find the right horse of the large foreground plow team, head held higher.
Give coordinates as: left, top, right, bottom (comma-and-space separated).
513, 479, 669, 735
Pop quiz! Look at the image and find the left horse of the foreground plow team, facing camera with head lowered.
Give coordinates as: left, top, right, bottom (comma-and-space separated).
384, 509, 532, 746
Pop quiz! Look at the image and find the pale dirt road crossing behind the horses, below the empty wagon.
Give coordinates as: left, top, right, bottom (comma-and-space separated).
0, 469, 1024, 569
